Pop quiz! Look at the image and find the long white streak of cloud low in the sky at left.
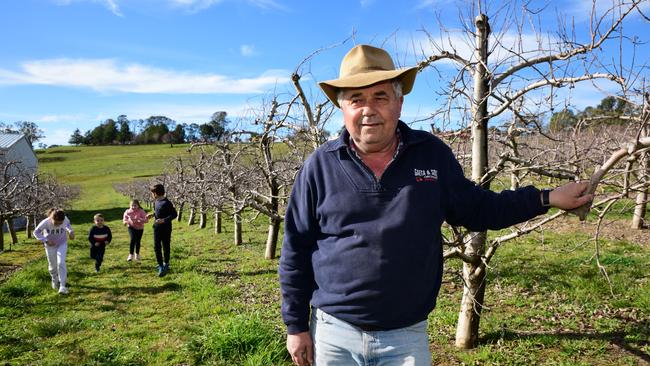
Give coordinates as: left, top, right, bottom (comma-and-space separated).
0, 59, 289, 94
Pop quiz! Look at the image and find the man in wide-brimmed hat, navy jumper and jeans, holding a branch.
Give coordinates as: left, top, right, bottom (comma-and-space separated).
279, 45, 593, 366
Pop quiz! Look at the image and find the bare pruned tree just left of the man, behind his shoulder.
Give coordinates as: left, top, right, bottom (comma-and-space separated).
228, 50, 334, 259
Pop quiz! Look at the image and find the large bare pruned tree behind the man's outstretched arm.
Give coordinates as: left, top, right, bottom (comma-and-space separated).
418, 0, 641, 348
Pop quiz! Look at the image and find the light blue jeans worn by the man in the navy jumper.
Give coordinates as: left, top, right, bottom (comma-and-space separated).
310, 309, 431, 366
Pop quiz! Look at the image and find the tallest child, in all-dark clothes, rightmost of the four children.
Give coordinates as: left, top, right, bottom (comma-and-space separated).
147, 184, 178, 277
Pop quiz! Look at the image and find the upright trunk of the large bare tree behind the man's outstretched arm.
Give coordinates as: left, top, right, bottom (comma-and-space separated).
456, 14, 490, 349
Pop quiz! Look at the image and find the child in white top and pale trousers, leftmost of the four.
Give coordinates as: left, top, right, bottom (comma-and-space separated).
34, 208, 74, 294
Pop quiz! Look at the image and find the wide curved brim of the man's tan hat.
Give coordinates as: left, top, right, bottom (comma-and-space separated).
318, 67, 418, 108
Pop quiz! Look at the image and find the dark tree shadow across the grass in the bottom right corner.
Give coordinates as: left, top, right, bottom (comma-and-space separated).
479, 320, 650, 362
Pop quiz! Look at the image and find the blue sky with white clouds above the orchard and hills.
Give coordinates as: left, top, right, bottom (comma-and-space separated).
0, 0, 650, 145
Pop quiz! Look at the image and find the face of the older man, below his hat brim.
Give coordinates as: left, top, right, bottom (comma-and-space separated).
340, 81, 404, 153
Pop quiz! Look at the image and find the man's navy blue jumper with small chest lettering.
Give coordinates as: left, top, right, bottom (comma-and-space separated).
279, 122, 547, 334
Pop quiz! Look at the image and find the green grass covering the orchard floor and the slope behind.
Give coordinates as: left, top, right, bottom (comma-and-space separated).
0, 145, 650, 365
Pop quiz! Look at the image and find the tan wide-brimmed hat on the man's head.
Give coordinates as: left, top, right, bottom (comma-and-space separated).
318, 45, 418, 108
